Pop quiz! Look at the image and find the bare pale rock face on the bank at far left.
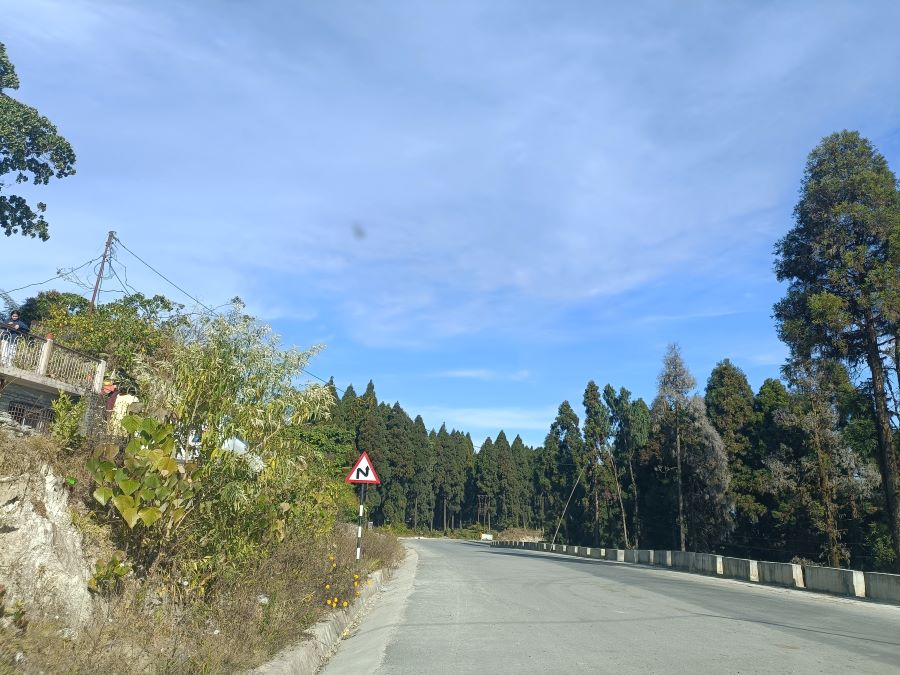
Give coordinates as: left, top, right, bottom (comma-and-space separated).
0, 466, 92, 627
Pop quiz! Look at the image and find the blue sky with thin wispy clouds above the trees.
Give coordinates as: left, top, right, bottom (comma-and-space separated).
0, 0, 900, 444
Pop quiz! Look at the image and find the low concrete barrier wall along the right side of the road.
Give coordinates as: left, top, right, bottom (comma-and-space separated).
491, 541, 900, 605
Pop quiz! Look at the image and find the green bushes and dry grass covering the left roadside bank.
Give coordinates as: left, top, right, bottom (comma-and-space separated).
0, 296, 402, 672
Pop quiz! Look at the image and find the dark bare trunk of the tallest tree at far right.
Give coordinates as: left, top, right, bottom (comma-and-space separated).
865, 314, 900, 571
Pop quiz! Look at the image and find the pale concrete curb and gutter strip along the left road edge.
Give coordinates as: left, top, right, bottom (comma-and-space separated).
250, 570, 390, 675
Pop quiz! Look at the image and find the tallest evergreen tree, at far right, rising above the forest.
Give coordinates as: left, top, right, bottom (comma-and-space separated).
775, 131, 900, 569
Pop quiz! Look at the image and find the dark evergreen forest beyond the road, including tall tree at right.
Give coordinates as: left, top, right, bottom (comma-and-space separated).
320, 131, 900, 570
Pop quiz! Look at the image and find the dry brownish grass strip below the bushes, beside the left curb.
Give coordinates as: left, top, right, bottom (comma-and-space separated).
0, 526, 403, 673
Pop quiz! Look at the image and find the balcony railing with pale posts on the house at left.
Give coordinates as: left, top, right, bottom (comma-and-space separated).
0, 329, 106, 392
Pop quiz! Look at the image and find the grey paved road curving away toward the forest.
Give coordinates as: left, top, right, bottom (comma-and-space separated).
324, 539, 900, 675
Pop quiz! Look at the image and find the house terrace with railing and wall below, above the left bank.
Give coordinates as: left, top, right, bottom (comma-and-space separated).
0, 329, 106, 431
